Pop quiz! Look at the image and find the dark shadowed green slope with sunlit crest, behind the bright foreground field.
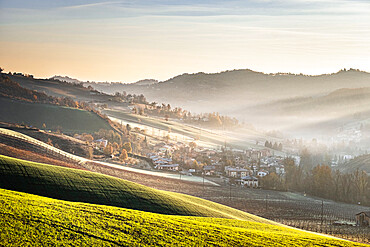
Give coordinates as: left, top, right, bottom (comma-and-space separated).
0, 155, 273, 224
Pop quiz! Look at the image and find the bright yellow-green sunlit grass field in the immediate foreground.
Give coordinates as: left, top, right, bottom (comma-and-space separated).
0, 189, 365, 246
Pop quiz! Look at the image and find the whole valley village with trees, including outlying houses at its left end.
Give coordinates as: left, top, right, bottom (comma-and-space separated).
87, 130, 285, 188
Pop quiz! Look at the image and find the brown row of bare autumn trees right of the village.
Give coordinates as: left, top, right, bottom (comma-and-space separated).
261, 158, 370, 206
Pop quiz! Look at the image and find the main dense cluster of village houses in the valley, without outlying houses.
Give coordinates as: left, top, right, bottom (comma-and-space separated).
147, 142, 285, 188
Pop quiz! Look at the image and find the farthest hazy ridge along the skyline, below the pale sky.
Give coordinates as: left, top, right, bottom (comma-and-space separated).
85, 69, 370, 112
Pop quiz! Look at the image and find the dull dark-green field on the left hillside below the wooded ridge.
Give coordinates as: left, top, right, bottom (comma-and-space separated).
0, 97, 111, 133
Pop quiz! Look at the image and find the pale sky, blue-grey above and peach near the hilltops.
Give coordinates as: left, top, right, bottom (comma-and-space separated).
0, 0, 370, 82
